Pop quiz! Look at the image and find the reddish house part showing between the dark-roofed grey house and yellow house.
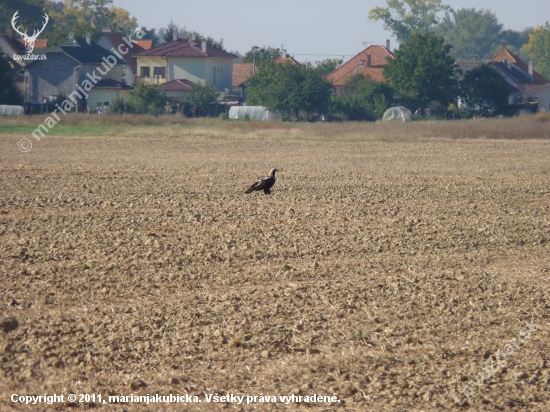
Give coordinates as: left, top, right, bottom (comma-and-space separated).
96, 29, 153, 86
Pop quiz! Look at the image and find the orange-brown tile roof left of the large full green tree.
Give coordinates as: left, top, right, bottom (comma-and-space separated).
326, 45, 394, 86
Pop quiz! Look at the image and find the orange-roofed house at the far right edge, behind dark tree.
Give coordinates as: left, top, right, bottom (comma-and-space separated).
457, 47, 550, 115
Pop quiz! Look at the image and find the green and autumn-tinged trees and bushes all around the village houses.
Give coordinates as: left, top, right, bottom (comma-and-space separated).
0, 0, 550, 120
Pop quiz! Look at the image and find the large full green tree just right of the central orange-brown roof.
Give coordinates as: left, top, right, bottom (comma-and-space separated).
384, 32, 458, 110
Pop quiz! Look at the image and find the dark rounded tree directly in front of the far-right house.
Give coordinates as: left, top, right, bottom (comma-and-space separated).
460, 65, 512, 117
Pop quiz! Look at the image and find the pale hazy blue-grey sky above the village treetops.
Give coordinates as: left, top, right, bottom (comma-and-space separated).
113, 0, 550, 62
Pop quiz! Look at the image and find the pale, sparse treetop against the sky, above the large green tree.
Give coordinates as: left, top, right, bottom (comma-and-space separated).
369, 0, 451, 44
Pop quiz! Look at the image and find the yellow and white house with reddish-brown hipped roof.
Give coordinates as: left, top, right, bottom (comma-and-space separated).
135, 37, 237, 91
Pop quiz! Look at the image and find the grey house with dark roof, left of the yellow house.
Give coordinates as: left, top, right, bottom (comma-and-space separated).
24, 36, 125, 112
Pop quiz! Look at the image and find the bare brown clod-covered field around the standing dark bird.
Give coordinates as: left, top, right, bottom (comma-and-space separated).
0, 130, 550, 411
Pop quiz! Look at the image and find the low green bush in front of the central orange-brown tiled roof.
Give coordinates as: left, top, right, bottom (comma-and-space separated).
332, 73, 393, 121
